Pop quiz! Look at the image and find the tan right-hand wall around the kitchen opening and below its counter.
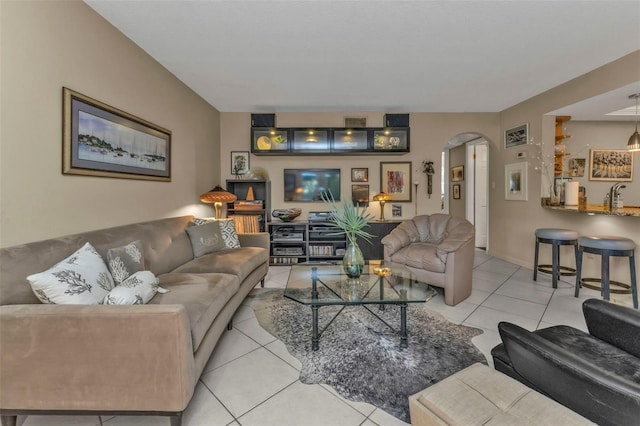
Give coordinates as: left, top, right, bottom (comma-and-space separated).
489, 51, 640, 282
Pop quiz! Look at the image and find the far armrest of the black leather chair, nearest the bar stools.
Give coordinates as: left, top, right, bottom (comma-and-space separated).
582, 299, 640, 358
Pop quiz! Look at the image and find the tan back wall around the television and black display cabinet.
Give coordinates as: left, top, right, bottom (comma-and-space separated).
220, 112, 499, 223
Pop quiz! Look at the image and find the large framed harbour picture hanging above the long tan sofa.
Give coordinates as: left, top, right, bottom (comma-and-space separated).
62, 87, 171, 182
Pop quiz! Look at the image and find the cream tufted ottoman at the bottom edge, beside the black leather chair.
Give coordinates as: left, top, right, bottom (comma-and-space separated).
409, 364, 594, 426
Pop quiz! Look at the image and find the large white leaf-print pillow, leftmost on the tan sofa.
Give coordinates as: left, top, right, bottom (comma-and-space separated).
27, 243, 114, 305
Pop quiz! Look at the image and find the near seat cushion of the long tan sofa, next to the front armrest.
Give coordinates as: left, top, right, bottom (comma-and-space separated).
149, 272, 240, 352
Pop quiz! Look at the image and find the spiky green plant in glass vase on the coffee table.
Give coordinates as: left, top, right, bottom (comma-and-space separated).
321, 192, 373, 278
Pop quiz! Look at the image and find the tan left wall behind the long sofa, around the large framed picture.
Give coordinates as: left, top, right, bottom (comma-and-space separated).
0, 1, 220, 246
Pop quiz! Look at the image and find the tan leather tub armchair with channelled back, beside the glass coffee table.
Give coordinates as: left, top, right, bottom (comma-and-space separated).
382, 214, 475, 306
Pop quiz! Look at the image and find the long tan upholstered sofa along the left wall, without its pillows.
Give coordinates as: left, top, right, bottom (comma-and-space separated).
0, 216, 269, 426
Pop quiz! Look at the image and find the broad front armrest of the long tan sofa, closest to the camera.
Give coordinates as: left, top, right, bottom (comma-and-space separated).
0, 304, 197, 412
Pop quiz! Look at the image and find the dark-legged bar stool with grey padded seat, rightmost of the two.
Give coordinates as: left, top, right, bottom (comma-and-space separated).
575, 235, 638, 309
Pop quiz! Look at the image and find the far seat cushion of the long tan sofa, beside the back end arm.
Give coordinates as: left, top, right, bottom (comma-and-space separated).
170, 247, 269, 285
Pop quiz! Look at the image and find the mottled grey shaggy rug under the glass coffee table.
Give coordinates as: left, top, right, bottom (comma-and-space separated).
247, 289, 486, 423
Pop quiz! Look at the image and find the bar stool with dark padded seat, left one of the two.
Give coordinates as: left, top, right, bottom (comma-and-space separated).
533, 228, 578, 288
